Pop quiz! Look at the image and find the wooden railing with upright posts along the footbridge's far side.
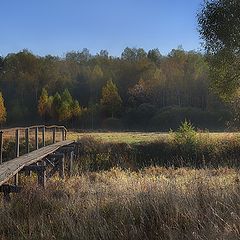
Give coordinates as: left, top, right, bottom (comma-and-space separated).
0, 125, 67, 164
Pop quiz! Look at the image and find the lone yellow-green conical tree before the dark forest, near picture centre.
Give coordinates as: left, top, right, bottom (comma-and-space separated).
101, 80, 122, 117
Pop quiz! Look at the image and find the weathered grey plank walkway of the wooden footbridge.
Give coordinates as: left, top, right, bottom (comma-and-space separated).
0, 140, 74, 186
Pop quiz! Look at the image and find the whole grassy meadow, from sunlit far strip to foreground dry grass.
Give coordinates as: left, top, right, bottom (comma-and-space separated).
0, 125, 240, 240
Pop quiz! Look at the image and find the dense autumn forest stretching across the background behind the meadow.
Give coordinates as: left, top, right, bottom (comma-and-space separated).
0, 48, 231, 130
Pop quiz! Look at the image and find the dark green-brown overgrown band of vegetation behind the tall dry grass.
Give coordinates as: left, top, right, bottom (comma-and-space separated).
74, 131, 240, 171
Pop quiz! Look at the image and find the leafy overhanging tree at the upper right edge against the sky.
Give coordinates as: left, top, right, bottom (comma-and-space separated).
198, 0, 240, 101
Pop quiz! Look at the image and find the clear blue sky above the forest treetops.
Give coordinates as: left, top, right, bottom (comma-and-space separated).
0, 0, 203, 56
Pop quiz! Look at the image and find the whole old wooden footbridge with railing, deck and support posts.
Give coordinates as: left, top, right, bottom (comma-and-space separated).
0, 125, 75, 201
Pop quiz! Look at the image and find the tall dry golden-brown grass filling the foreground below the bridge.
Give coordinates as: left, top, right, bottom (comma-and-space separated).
0, 167, 240, 240
